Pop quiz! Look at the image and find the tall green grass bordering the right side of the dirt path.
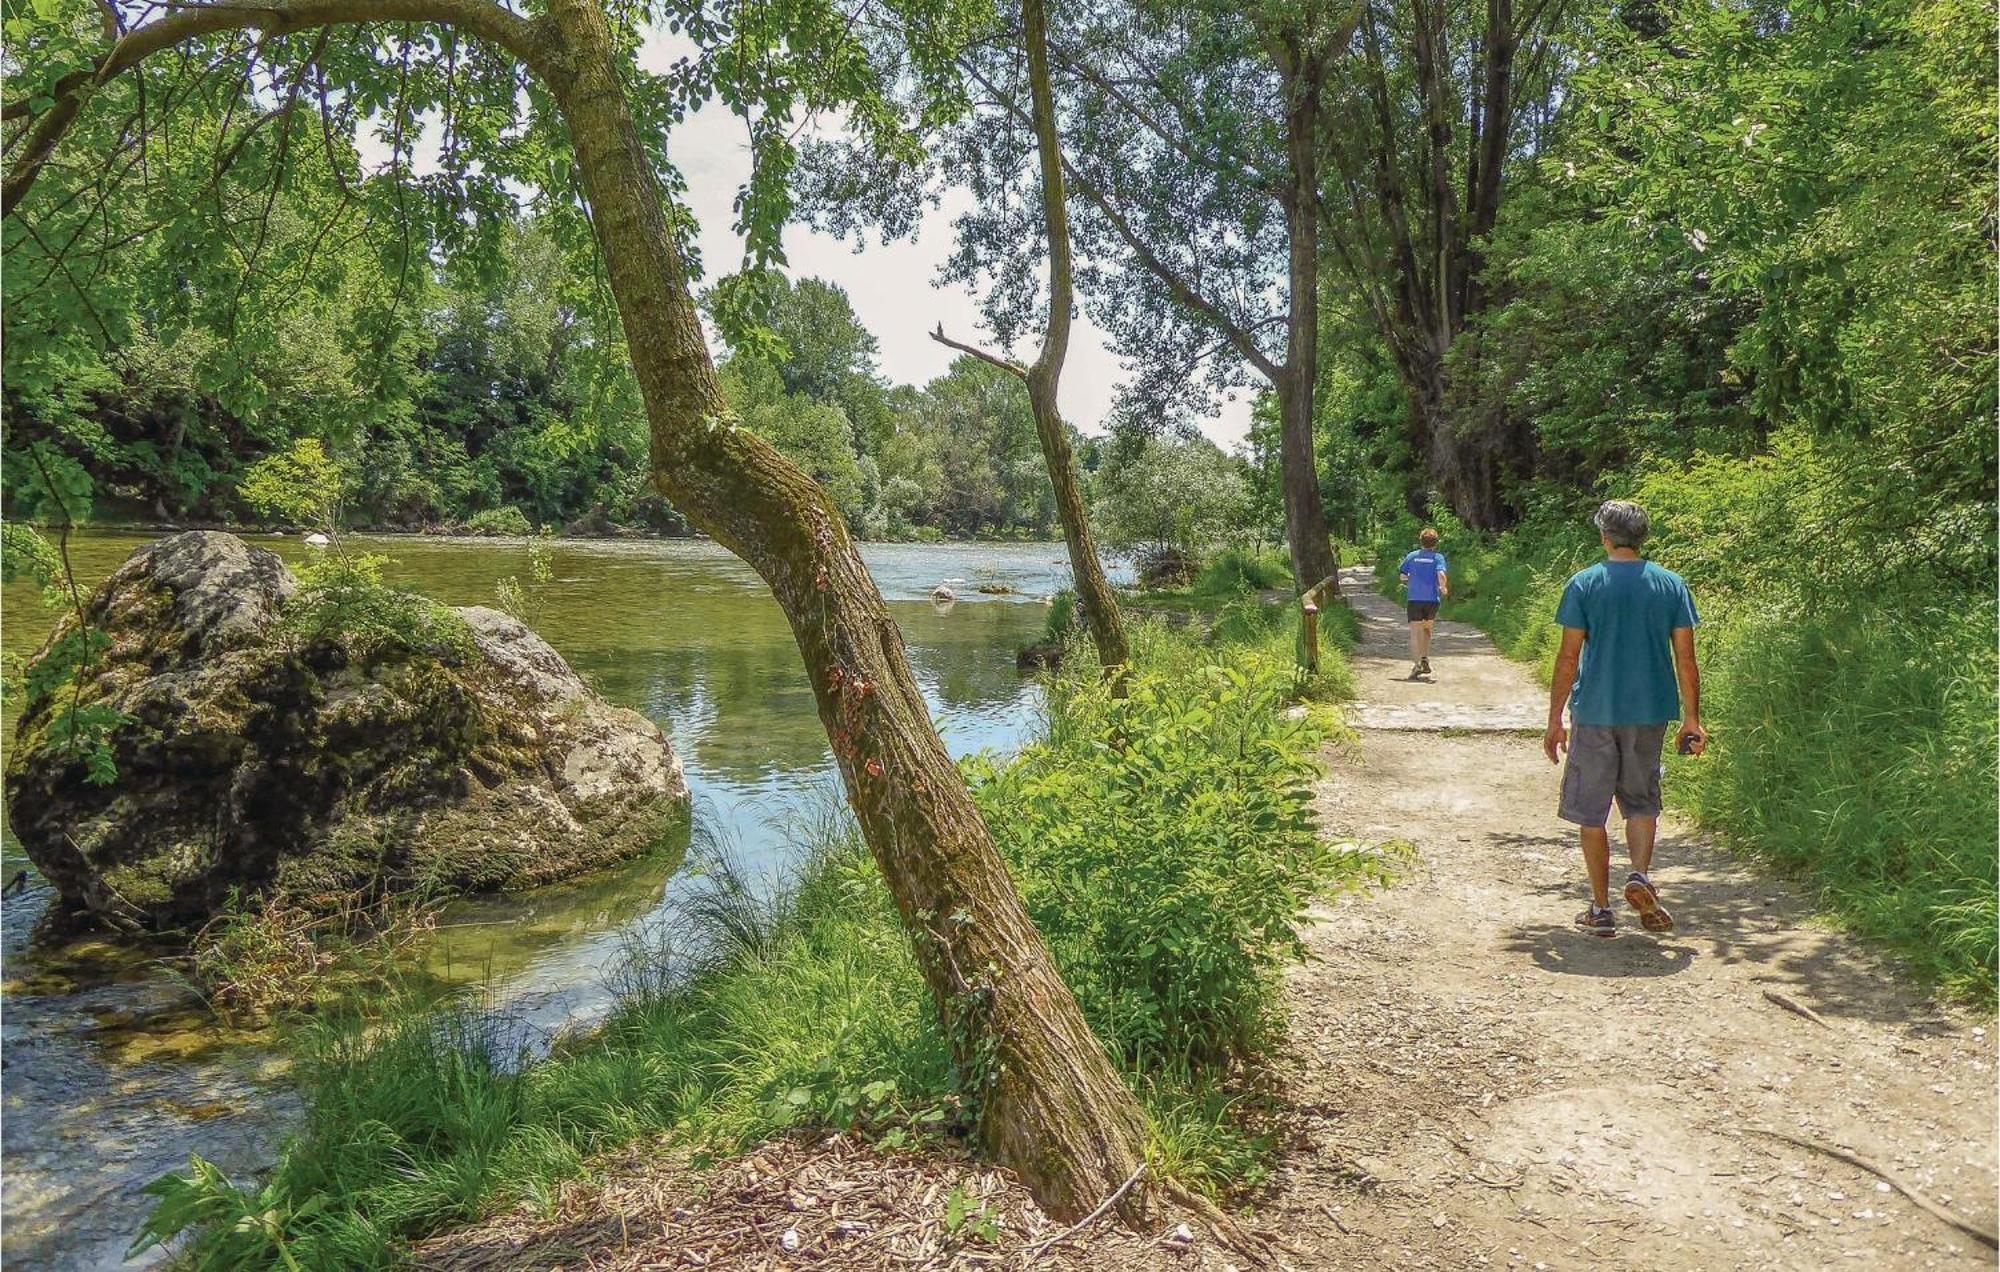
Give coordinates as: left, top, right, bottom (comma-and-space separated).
1378, 528, 2000, 1010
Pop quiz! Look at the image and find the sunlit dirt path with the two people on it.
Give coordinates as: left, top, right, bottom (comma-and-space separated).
1258, 570, 1996, 1270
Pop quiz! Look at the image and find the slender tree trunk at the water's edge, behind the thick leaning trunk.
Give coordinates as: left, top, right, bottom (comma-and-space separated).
1020, 0, 1126, 692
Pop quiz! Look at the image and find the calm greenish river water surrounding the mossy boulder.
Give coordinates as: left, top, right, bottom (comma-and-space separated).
0, 534, 1112, 1268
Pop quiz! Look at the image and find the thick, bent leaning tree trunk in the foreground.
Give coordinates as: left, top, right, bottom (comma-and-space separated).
544, 0, 1144, 1216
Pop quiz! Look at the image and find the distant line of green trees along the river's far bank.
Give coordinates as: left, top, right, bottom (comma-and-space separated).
0, 218, 1244, 546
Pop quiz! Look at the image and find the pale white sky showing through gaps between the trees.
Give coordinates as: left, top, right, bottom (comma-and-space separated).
642, 98, 1250, 450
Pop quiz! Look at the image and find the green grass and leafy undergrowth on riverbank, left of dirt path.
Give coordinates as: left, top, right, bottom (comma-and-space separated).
146, 602, 1366, 1268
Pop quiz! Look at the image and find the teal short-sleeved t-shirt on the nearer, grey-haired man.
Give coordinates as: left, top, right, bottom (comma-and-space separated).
1556, 560, 1698, 724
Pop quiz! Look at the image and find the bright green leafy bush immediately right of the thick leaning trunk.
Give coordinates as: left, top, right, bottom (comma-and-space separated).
968, 632, 1336, 1068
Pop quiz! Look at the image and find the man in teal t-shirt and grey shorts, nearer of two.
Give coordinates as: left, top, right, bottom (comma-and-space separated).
1542, 500, 1708, 936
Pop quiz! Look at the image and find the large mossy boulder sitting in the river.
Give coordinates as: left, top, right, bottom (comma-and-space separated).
6, 532, 688, 928
